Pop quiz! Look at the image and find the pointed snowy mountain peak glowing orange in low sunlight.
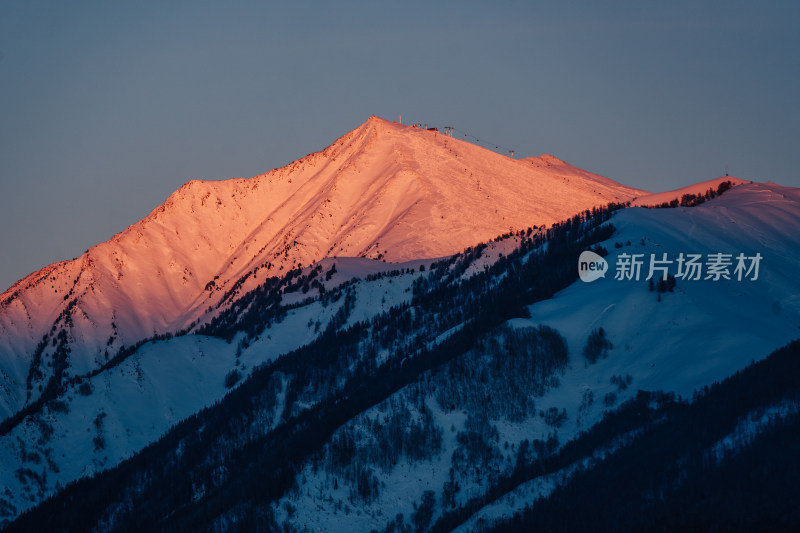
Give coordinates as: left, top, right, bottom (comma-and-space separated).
0, 117, 643, 418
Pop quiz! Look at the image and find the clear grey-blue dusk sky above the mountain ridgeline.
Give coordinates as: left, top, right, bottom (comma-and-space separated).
0, 0, 800, 291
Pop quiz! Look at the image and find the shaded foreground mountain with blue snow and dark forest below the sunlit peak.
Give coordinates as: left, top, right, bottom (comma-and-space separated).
0, 184, 800, 531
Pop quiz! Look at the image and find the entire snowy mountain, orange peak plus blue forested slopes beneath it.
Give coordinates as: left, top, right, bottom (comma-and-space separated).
0, 117, 800, 531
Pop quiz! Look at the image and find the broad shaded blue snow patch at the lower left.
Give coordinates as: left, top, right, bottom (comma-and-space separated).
0, 337, 234, 511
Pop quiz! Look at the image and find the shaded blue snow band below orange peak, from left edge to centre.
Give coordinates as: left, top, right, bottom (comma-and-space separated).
0, 258, 421, 524
